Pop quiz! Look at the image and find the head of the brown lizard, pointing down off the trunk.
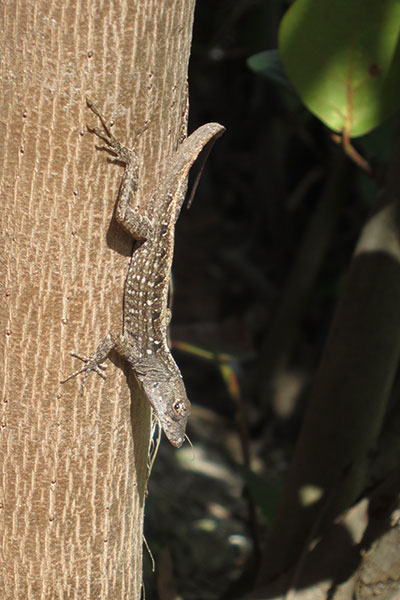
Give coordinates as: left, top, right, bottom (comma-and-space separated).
136, 360, 190, 448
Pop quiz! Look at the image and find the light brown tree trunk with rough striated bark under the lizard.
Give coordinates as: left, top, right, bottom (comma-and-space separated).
0, 0, 198, 600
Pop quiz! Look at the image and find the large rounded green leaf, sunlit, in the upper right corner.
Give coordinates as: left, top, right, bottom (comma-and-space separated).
279, 0, 400, 137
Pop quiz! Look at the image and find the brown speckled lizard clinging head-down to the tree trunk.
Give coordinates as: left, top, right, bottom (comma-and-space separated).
63, 100, 225, 448
